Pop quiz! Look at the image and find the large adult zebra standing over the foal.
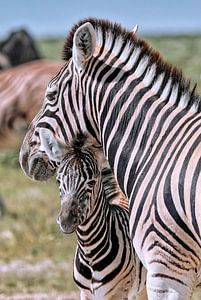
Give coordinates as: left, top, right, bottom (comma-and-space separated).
20, 19, 201, 300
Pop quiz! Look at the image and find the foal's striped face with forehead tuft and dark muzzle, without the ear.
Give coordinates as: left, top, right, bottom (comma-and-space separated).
57, 136, 101, 233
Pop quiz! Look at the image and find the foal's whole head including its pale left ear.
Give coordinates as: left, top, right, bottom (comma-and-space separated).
40, 129, 105, 233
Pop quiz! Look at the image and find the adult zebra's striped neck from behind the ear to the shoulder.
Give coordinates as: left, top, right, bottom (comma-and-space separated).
76, 25, 200, 195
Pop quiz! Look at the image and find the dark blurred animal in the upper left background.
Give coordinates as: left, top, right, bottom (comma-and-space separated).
0, 29, 41, 69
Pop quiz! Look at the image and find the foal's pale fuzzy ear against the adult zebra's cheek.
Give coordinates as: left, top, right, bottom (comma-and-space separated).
39, 128, 67, 162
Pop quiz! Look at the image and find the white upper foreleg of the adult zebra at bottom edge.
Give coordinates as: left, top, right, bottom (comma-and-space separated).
147, 272, 192, 300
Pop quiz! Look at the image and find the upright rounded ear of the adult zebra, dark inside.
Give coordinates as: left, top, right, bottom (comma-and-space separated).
73, 22, 96, 69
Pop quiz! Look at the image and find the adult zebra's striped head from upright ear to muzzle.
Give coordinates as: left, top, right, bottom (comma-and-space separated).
19, 23, 98, 180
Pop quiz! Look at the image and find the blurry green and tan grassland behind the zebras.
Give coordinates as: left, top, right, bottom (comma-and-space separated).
0, 36, 201, 300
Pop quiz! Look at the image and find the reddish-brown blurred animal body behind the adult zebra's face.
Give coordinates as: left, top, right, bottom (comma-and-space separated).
0, 60, 62, 149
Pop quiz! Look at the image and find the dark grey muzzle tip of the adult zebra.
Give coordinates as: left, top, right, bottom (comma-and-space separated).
28, 156, 56, 181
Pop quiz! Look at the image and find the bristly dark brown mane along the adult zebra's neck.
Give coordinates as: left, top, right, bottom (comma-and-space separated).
63, 18, 201, 112
